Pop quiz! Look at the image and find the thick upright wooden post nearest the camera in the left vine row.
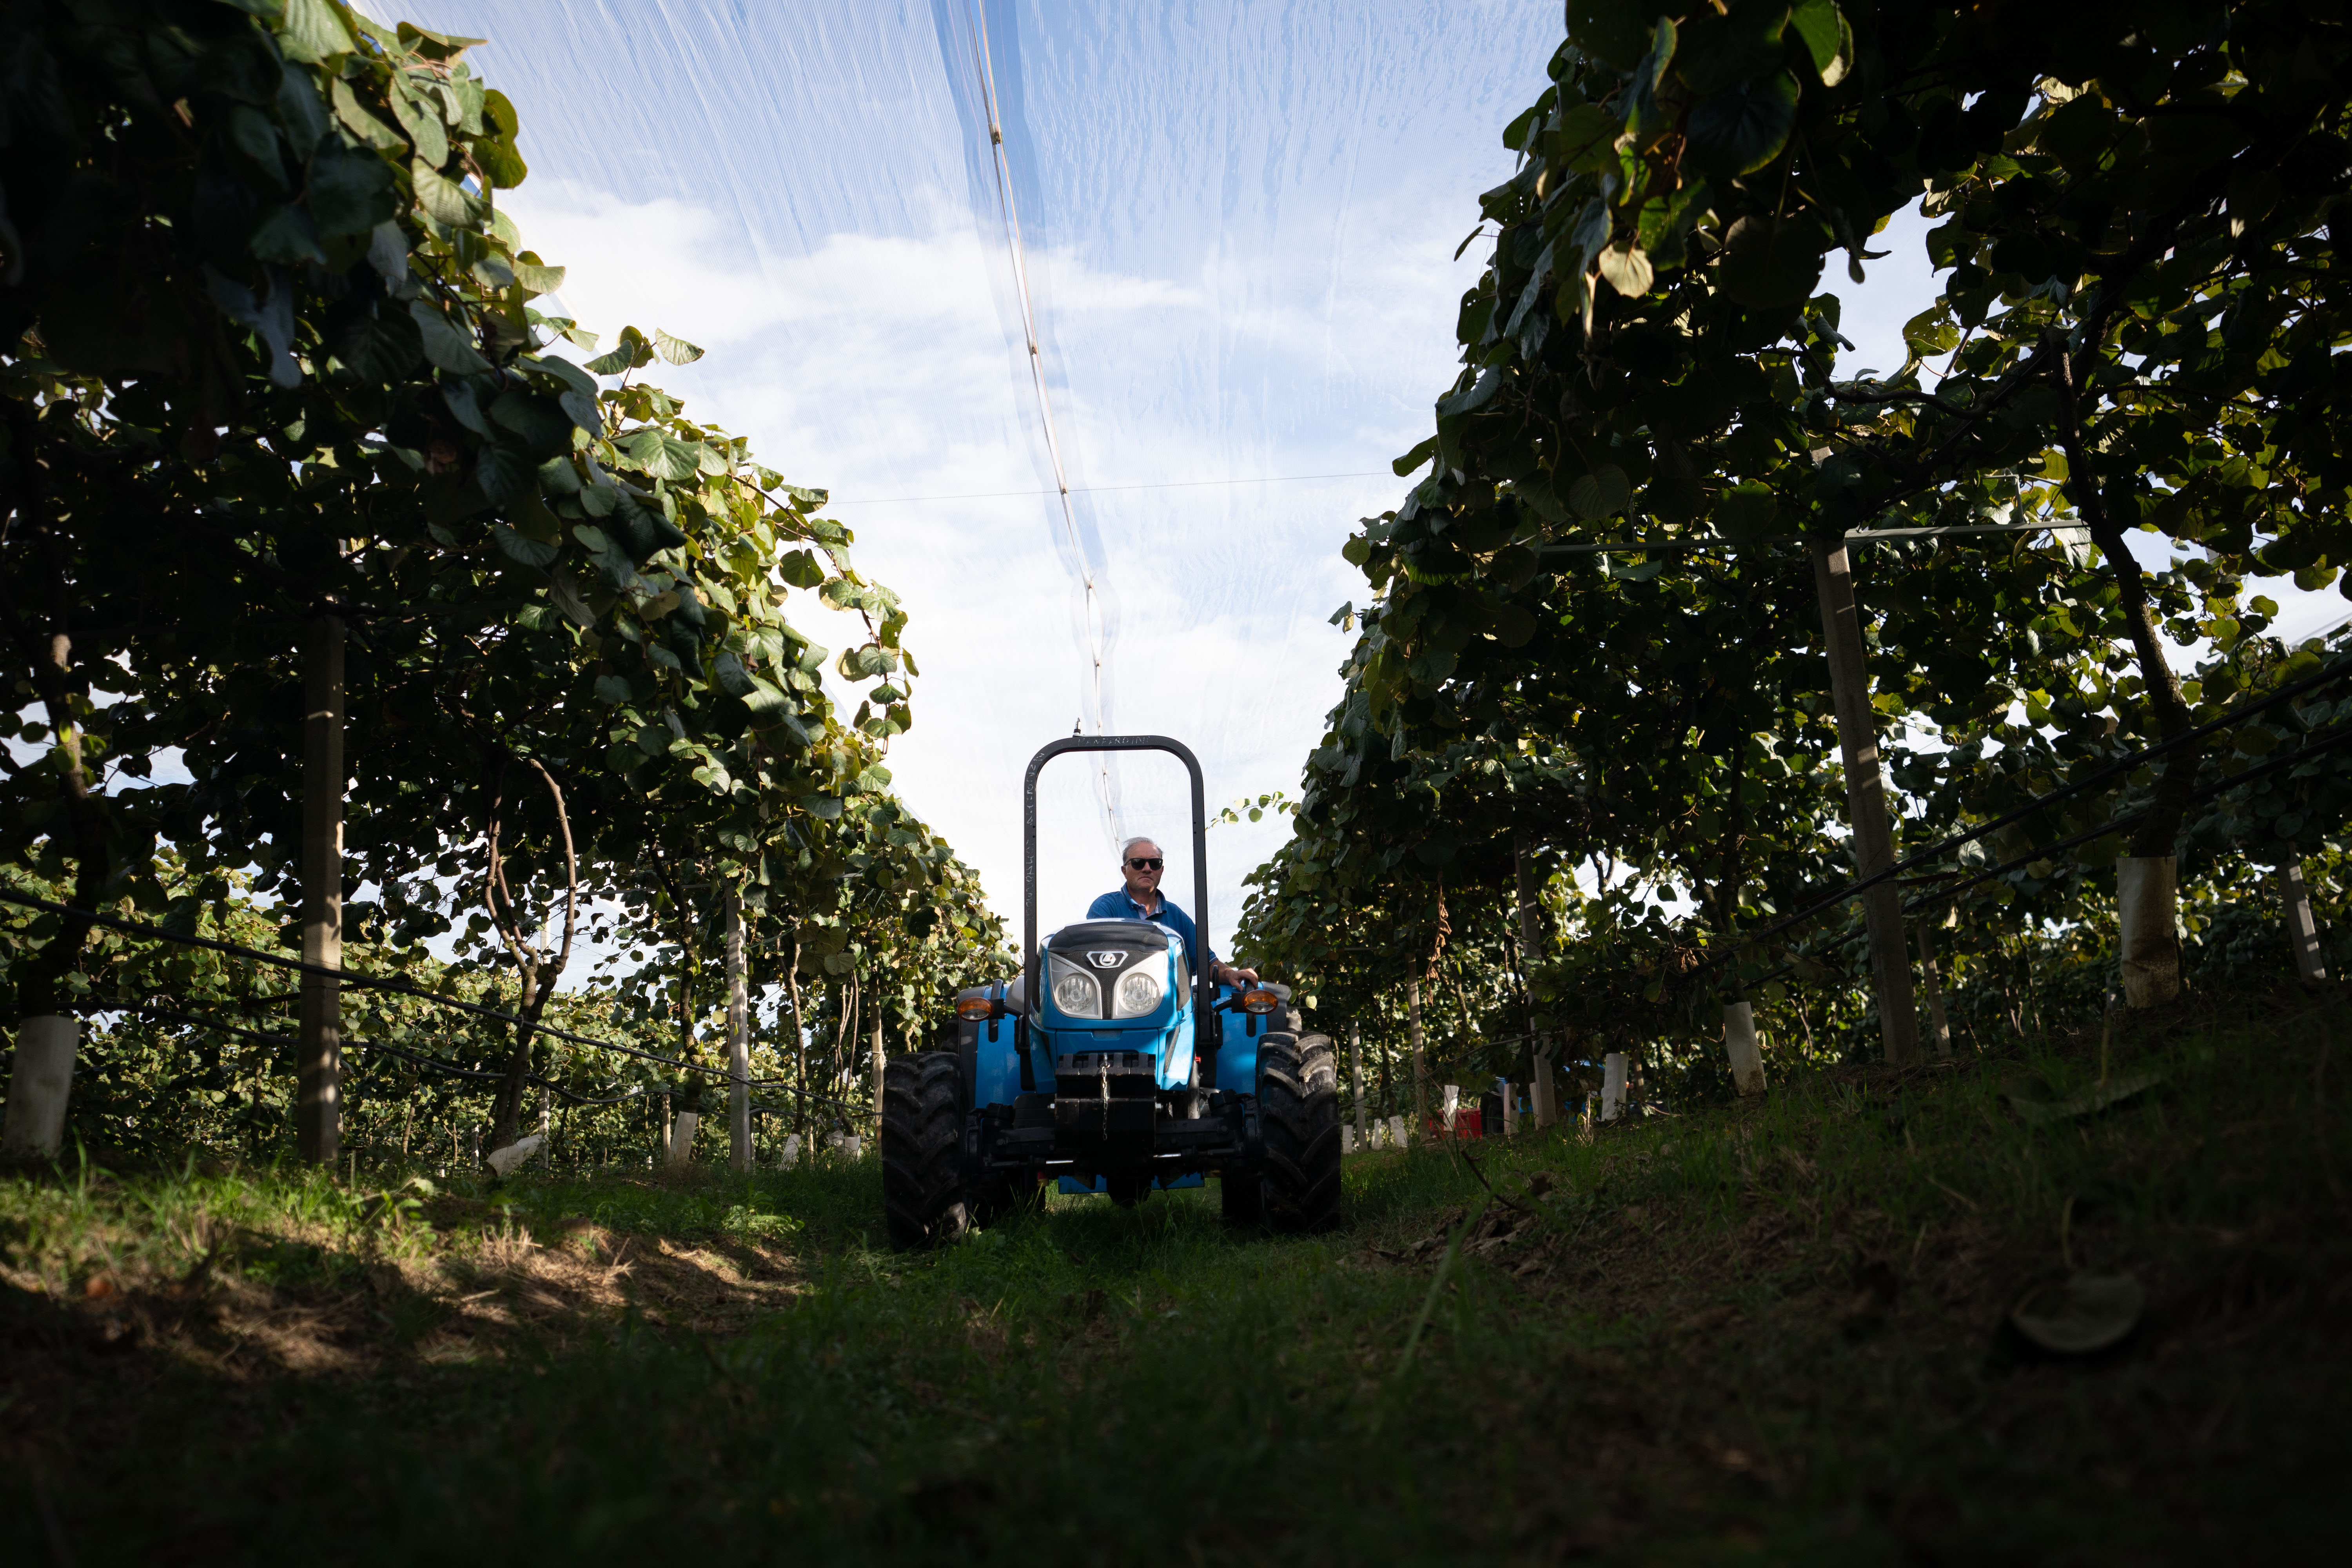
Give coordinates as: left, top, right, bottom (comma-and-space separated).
294, 616, 343, 1166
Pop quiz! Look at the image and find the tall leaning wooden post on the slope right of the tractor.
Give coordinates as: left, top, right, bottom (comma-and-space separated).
1813, 538, 1919, 1065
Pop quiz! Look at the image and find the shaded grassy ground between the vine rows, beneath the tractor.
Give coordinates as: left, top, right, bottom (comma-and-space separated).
0, 999, 2352, 1563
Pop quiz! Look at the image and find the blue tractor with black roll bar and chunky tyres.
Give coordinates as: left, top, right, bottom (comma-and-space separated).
882, 736, 1338, 1248
